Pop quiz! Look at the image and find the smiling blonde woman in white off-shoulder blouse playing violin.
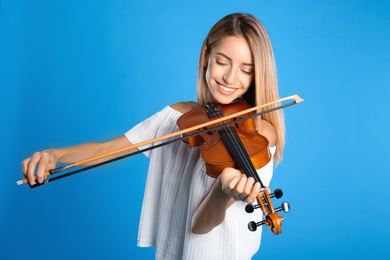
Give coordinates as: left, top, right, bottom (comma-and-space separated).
22, 13, 284, 259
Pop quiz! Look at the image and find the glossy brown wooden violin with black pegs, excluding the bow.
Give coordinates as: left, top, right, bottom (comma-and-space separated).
177, 99, 290, 235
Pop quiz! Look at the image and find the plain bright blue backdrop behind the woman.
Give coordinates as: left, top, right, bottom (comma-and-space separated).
0, 0, 390, 259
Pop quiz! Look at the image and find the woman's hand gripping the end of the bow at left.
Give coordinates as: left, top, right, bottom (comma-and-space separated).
22, 150, 58, 185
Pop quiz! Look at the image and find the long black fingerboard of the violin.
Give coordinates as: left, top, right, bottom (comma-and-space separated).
218, 127, 264, 188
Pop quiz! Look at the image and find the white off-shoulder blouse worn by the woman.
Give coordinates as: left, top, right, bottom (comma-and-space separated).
125, 106, 276, 260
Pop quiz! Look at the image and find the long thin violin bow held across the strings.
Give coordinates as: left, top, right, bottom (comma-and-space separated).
16, 95, 303, 188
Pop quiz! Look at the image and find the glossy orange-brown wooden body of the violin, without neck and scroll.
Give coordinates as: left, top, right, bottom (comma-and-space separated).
177, 100, 271, 178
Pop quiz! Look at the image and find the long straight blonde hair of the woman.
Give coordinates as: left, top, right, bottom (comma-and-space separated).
197, 13, 285, 164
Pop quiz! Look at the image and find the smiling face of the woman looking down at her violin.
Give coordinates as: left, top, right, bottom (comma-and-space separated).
206, 36, 254, 104
